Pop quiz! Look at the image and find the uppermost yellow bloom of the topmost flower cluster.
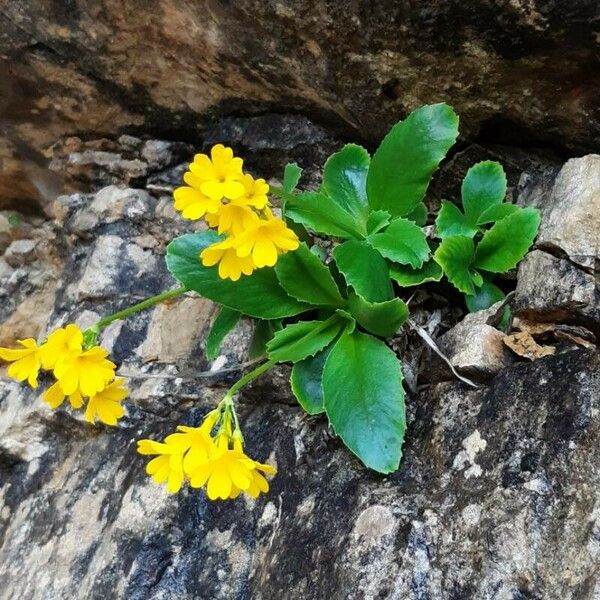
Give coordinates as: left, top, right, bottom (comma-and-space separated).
190, 144, 244, 200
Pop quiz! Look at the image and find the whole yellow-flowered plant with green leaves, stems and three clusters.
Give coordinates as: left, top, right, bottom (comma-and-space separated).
0, 104, 540, 500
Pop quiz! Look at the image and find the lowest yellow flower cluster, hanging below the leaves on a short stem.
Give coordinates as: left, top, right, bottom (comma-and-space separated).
138, 405, 276, 500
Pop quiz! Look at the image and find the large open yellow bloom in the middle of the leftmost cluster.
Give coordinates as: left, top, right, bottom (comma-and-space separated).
54, 346, 116, 396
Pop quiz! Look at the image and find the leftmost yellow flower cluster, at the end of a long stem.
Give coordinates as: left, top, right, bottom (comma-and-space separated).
0, 324, 127, 425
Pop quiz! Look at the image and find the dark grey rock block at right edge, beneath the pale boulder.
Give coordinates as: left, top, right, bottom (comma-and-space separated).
514, 250, 600, 329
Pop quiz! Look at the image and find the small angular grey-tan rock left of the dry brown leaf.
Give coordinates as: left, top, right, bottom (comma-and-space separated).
438, 303, 512, 379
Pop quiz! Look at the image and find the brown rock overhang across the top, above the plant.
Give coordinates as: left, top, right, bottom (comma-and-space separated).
0, 0, 600, 211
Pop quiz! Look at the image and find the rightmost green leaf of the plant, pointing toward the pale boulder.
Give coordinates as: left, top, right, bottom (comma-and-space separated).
473, 208, 540, 273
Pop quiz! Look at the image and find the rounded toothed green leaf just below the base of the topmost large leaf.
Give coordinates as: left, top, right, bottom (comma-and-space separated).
367, 219, 429, 269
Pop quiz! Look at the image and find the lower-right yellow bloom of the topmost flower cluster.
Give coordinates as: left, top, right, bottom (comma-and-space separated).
235, 217, 300, 269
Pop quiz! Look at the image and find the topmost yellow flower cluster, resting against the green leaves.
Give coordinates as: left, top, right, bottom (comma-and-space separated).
173, 144, 299, 281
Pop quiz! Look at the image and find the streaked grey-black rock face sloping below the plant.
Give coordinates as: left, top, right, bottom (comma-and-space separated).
0, 344, 600, 600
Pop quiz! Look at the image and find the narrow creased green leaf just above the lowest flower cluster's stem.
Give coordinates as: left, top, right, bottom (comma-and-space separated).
267, 315, 348, 363
